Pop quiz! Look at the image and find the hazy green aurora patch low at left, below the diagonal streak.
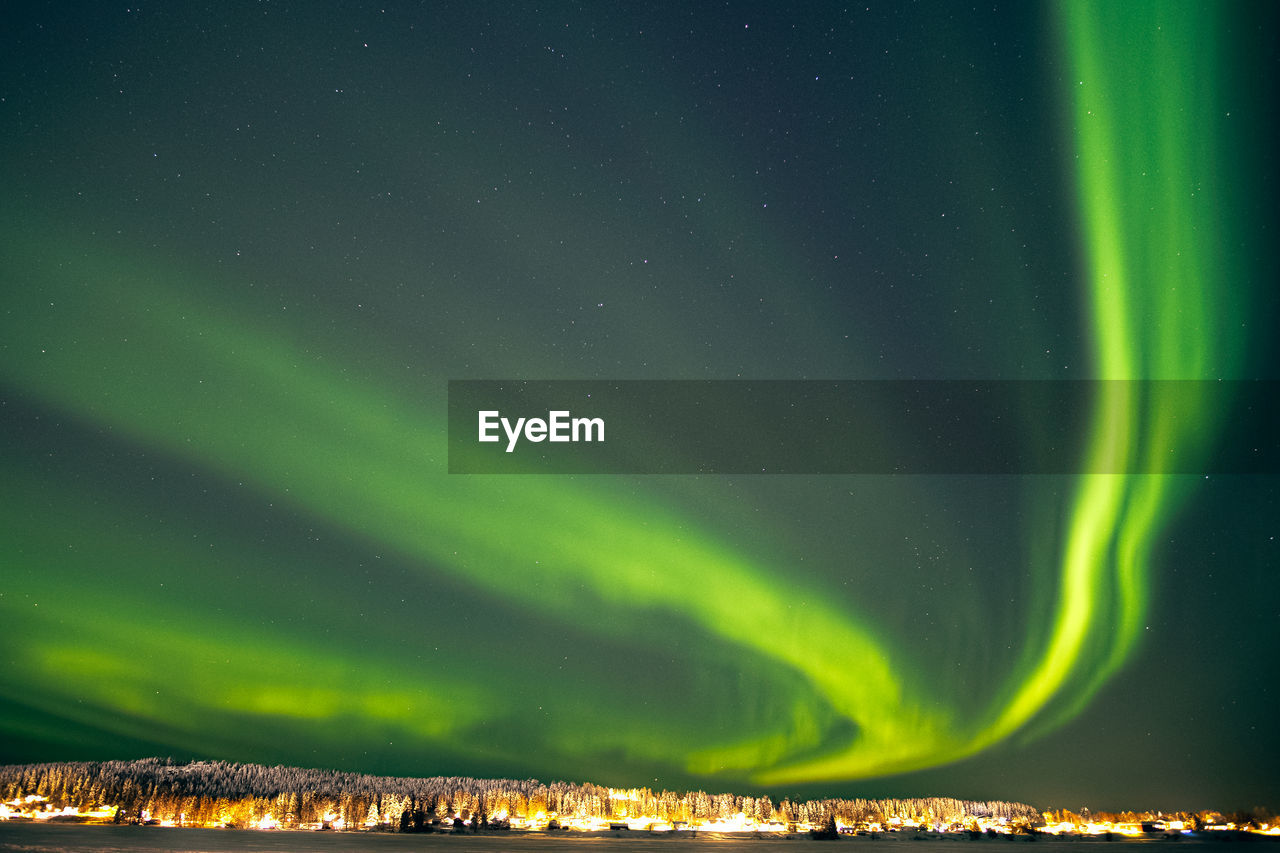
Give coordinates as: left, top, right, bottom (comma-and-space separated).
0, 478, 503, 754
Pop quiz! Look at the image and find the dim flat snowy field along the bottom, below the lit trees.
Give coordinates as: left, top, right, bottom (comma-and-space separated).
0, 822, 1280, 853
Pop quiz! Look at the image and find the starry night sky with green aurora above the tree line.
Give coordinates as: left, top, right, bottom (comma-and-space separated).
0, 0, 1280, 811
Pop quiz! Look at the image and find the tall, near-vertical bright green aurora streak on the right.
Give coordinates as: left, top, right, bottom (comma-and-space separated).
980, 1, 1240, 742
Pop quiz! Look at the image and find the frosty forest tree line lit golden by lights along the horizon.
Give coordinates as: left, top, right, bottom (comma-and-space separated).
0, 758, 1039, 830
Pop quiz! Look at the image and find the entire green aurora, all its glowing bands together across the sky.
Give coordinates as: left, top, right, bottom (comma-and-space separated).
0, 3, 1259, 785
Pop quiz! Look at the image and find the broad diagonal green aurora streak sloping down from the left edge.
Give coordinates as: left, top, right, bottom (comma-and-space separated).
3, 229, 954, 774
